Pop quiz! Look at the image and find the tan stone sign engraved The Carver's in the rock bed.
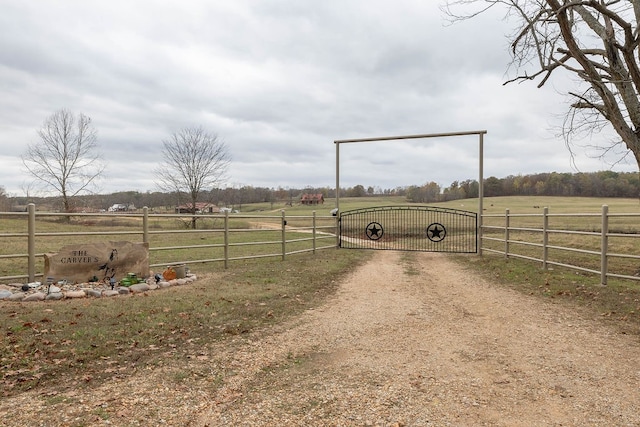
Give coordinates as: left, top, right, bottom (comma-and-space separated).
44, 242, 149, 283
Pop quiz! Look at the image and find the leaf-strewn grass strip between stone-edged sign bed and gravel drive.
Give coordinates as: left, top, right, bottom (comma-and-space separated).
0, 249, 370, 396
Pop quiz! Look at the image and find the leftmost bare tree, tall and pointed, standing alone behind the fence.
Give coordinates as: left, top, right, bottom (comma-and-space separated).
22, 109, 105, 212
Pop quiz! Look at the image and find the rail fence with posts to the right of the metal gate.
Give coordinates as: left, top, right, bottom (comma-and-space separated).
481, 205, 640, 285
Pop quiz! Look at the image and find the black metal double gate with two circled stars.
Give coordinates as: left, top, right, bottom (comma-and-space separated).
340, 206, 478, 253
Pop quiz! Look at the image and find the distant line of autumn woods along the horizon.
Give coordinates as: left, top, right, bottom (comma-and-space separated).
7, 171, 640, 211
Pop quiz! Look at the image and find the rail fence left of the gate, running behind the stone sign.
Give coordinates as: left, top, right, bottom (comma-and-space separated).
0, 204, 337, 282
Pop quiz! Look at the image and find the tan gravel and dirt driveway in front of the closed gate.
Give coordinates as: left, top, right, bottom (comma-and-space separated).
197, 252, 640, 426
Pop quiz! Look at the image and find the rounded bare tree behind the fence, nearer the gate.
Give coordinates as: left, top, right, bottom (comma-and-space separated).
156, 127, 230, 229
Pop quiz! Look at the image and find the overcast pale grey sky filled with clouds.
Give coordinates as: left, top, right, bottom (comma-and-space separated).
0, 0, 637, 195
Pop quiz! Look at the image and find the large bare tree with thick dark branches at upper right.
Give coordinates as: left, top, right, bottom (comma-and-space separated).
443, 0, 640, 171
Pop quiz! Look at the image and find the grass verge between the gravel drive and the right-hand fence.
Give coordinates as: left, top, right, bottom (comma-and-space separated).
454, 254, 640, 334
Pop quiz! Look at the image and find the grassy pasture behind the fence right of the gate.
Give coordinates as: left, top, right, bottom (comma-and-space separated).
472, 197, 640, 281
